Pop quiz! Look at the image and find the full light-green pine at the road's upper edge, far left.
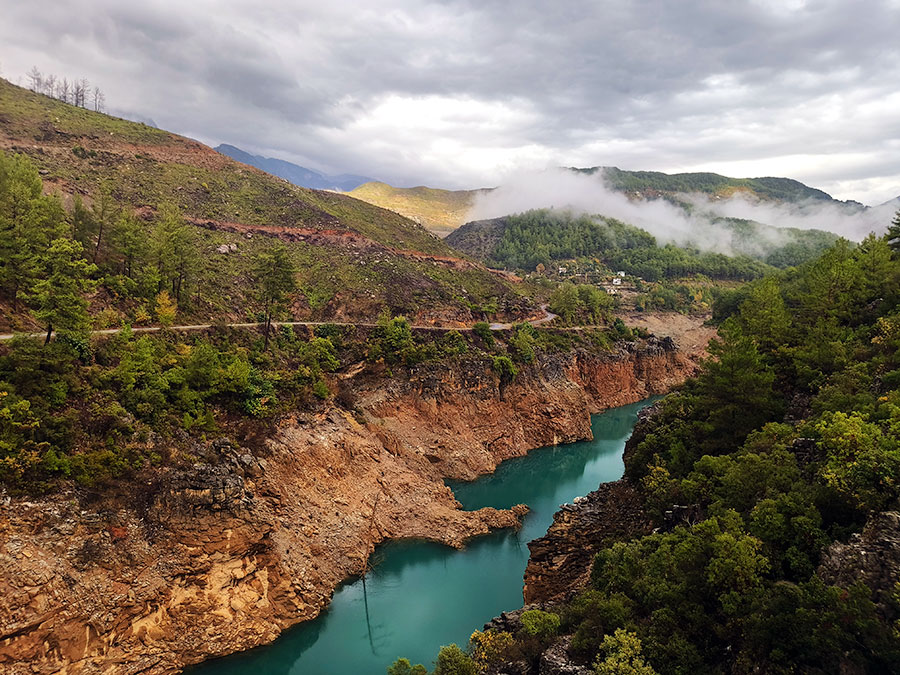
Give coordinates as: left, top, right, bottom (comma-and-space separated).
31, 238, 97, 344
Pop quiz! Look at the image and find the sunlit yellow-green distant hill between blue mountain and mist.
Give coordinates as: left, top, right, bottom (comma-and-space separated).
348, 182, 490, 237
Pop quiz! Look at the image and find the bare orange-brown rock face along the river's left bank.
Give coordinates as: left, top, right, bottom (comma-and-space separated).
0, 340, 712, 675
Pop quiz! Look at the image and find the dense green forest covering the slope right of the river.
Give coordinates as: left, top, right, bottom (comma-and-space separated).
398, 220, 900, 675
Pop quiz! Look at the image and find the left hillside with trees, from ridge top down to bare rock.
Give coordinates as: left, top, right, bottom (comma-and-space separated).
0, 81, 556, 500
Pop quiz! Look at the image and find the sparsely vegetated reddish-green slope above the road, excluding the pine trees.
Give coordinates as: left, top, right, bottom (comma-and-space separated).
0, 80, 520, 328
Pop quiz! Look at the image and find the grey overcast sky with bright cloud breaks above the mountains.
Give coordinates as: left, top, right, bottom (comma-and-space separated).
0, 0, 900, 204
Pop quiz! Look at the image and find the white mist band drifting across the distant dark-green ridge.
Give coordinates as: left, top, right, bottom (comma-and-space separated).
469, 167, 897, 253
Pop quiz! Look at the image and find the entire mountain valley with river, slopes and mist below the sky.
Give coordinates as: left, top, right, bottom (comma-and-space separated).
0, 55, 900, 675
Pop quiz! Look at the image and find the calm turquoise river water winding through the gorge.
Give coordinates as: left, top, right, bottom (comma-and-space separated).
187, 401, 650, 675
